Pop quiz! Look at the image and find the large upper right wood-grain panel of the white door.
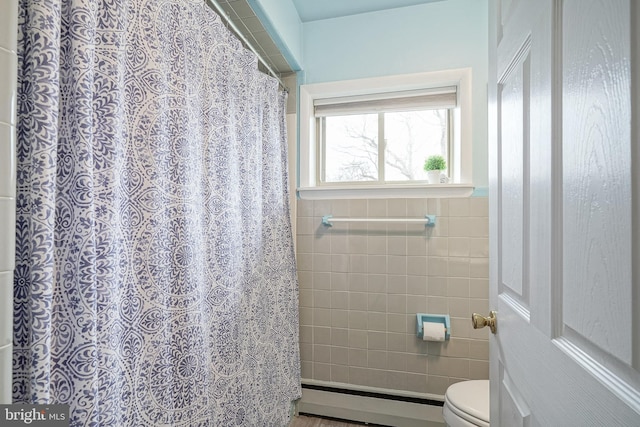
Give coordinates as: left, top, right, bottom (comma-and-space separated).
562, 0, 633, 364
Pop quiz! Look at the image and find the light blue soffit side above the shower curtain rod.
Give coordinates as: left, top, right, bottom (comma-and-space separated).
248, 0, 304, 71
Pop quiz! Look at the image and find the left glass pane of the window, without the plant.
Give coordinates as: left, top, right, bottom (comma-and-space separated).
323, 114, 378, 182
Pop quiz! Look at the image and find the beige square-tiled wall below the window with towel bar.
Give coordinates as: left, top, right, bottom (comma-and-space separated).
297, 198, 489, 395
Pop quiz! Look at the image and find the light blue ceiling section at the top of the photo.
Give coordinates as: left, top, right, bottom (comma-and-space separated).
292, 0, 442, 22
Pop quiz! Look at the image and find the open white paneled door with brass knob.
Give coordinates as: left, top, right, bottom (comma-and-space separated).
485, 0, 640, 427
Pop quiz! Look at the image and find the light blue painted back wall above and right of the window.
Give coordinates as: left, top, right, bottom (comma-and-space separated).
302, 0, 488, 187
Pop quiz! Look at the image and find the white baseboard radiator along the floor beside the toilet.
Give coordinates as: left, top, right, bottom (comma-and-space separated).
296, 380, 444, 427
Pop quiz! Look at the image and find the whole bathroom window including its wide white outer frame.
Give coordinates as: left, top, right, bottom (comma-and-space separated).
298, 70, 473, 198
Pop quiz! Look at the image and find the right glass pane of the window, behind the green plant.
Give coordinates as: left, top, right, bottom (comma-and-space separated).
384, 109, 449, 181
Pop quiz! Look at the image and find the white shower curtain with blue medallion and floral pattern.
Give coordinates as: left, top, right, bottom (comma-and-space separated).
13, 0, 300, 427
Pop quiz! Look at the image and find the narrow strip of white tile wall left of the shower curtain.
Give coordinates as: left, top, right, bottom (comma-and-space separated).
0, 0, 18, 404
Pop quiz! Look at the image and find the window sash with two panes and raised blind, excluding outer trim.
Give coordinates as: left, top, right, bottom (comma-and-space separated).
314, 86, 456, 185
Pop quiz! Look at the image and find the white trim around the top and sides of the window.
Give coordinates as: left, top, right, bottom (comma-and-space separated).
298, 68, 473, 198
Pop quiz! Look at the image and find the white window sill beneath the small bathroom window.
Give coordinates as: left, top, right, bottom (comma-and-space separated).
298, 184, 474, 200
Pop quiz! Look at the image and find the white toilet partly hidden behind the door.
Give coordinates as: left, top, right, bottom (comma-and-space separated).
442, 380, 489, 427
